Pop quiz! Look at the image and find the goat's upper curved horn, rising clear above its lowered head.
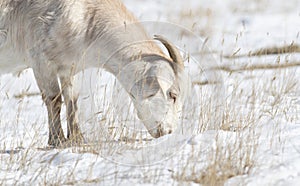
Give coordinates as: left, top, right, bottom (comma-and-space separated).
154, 35, 184, 69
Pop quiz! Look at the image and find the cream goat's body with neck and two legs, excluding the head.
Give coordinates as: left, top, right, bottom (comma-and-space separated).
0, 0, 184, 145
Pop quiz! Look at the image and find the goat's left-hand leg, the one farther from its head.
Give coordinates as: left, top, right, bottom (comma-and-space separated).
33, 65, 66, 147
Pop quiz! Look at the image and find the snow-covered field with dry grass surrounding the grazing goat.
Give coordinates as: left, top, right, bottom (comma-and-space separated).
0, 0, 300, 185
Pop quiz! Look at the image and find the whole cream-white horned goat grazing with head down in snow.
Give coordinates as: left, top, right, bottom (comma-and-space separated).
0, 0, 188, 146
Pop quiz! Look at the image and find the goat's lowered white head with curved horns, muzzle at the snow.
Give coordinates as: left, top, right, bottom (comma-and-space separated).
129, 36, 188, 138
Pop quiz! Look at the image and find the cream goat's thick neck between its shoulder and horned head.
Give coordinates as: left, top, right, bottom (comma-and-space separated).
85, 32, 167, 84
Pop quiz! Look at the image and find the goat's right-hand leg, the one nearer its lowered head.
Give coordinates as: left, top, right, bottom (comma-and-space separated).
60, 77, 84, 144
